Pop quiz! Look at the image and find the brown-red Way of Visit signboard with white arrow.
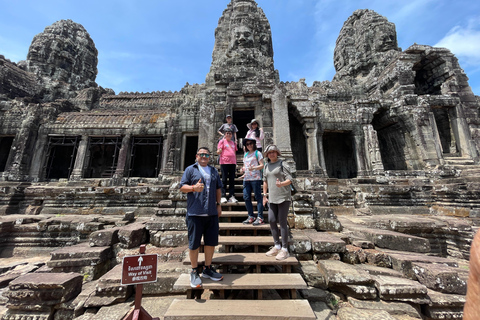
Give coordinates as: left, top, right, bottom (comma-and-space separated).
122, 254, 158, 285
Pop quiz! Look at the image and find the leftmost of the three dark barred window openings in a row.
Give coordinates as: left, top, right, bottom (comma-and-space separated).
45, 136, 80, 179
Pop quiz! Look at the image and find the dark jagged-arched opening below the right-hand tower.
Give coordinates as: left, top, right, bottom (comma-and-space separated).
372, 110, 407, 170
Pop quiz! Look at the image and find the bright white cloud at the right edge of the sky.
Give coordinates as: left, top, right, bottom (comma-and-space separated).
434, 18, 480, 65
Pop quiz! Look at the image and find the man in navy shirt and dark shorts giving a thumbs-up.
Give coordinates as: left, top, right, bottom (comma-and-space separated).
180, 147, 223, 288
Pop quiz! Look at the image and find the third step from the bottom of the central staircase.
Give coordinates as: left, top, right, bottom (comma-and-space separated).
183, 252, 298, 273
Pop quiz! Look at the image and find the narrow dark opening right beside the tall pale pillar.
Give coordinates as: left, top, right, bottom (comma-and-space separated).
288, 108, 308, 170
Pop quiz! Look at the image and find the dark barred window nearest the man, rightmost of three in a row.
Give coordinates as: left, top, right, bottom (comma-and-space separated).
129, 136, 163, 178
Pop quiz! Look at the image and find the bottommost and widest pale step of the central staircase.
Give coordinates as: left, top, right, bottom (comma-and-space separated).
164, 299, 316, 320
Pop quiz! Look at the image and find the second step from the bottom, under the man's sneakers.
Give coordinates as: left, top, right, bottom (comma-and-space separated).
173, 273, 307, 299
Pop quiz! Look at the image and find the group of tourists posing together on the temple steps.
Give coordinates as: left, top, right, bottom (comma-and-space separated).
180, 115, 293, 288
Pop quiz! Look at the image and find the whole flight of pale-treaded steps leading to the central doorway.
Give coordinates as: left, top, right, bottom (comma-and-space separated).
164, 170, 316, 320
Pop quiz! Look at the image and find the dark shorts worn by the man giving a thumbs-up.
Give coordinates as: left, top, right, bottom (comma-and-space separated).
186, 215, 219, 250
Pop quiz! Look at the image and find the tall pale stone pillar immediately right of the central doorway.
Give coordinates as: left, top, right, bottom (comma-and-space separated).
272, 86, 296, 171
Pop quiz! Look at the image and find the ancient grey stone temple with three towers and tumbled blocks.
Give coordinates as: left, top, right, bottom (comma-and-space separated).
0, 0, 480, 320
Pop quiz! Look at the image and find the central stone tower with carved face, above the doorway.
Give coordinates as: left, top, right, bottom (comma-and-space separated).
199, 0, 291, 165
